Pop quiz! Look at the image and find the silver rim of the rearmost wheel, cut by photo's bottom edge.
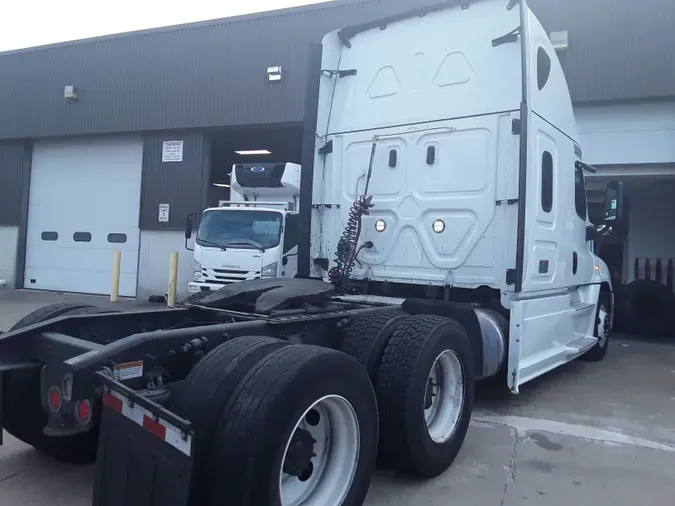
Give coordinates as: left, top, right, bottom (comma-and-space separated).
279, 395, 361, 506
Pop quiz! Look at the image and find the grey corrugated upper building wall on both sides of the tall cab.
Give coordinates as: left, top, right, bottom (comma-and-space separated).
0, 0, 675, 138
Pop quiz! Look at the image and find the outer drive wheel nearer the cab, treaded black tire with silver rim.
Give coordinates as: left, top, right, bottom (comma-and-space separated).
376, 315, 475, 477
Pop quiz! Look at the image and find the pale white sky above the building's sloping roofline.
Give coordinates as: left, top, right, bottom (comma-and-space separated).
0, 0, 325, 51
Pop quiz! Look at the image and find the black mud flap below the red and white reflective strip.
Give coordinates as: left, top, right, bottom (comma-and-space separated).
92, 406, 193, 506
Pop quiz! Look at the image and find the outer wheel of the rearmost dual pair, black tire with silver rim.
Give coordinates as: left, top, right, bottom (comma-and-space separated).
200, 345, 378, 506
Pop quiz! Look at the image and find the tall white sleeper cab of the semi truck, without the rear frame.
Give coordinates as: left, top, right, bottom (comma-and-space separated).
308, 0, 625, 392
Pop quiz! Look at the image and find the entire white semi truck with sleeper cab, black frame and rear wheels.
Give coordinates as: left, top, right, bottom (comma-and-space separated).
0, 0, 626, 506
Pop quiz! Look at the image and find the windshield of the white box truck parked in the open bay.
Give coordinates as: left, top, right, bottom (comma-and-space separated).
197, 209, 283, 250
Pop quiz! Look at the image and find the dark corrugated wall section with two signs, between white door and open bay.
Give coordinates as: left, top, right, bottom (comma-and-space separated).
140, 132, 209, 230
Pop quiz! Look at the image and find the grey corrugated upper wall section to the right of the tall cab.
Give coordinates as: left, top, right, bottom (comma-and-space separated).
528, 0, 675, 102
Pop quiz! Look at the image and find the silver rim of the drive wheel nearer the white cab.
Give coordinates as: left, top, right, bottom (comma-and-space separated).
424, 350, 465, 444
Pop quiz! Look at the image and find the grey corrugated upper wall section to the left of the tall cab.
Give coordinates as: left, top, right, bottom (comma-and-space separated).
0, 0, 433, 138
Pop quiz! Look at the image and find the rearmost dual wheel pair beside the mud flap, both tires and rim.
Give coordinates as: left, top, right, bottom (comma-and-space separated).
173, 336, 378, 506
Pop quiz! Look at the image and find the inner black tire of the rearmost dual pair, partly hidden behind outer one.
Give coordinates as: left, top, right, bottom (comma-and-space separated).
170, 336, 290, 498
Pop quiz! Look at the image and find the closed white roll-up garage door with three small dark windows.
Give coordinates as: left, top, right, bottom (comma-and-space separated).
24, 138, 143, 297
